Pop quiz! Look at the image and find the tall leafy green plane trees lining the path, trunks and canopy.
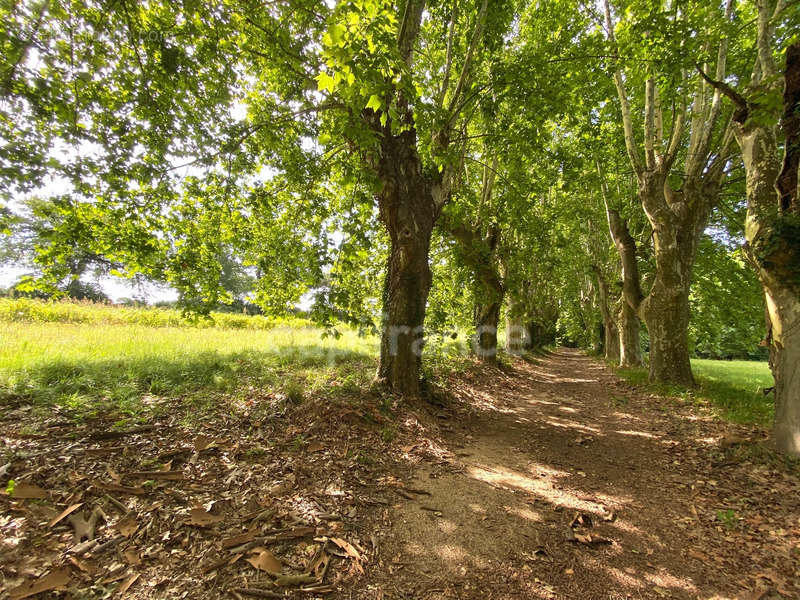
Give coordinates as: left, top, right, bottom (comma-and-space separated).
0, 0, 800, 453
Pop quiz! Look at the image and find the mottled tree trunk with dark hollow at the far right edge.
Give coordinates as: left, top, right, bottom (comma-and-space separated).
735, 39, 800, 456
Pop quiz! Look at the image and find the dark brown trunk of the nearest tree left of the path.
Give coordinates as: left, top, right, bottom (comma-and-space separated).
377, 129, 438, 397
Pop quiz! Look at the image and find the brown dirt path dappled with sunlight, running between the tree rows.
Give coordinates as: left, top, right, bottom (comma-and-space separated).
373, 350, 800, 600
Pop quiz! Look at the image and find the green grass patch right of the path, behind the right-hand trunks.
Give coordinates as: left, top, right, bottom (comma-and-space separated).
617, 359, 775, 425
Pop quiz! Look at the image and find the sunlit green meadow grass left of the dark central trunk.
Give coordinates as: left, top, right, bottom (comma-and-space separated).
0, 322, 377, 418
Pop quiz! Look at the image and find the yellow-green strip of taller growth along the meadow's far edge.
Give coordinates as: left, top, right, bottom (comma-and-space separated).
0, 298, 315, 329
